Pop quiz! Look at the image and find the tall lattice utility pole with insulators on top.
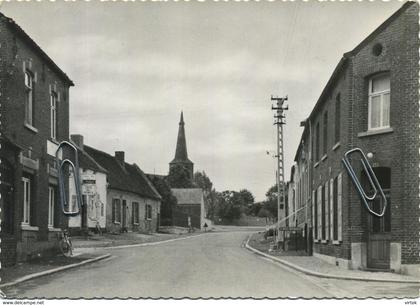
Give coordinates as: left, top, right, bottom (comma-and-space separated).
271, 95, 289, 246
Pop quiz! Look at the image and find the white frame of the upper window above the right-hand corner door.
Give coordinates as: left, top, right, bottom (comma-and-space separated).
368, 72, 391, 131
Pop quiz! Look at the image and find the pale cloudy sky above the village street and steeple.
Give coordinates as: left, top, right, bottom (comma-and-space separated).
0, 0, 403, 201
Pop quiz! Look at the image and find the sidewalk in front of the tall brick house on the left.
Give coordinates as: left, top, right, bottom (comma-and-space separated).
0, 251, 110, 287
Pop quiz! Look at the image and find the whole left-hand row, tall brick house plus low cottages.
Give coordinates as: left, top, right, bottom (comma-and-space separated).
0, 13, 161, 266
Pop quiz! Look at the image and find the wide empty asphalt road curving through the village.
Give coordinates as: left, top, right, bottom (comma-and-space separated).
4, 230, 419, 298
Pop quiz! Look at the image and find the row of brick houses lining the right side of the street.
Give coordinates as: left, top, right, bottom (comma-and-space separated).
287, 2, 420, 275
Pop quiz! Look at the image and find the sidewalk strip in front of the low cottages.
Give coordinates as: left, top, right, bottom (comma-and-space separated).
71, 231, 204, 249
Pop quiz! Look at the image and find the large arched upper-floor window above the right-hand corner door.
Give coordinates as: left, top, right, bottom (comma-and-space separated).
368, 73, 390, 130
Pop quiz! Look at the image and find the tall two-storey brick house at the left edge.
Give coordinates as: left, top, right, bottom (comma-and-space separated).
0, 13, 74, 265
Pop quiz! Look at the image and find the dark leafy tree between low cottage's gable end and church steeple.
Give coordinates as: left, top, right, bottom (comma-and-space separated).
147, 175, 177, 226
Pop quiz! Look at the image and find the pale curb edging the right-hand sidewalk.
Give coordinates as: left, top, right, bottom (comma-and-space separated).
245, 235, 420, 284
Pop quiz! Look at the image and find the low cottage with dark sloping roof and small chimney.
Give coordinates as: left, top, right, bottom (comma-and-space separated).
83, 145, 161, 233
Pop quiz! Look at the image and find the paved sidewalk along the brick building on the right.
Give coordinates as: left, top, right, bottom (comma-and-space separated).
246, 233, 420, 284
